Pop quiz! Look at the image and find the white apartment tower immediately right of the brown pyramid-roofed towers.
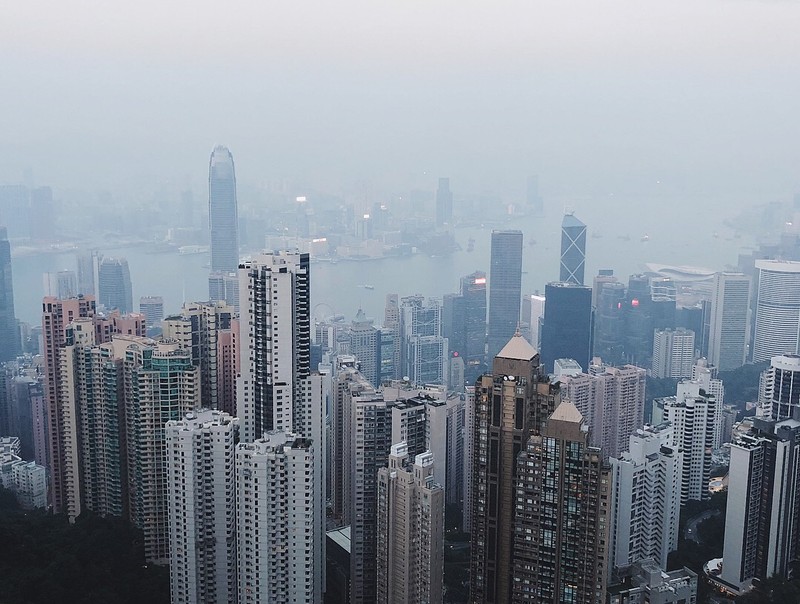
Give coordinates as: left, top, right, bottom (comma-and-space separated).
609, 424, 683, 570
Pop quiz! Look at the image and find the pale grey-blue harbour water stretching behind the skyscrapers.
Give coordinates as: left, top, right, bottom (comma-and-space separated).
13, 200, 753, 324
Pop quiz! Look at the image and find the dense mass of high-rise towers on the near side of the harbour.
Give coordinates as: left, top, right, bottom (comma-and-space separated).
0, 146, 800, 604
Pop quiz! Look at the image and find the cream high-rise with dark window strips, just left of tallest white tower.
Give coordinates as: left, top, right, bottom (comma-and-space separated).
162, 302, 238, 415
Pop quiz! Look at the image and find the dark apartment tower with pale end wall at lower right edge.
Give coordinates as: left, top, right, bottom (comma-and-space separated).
719, 418, 800, 593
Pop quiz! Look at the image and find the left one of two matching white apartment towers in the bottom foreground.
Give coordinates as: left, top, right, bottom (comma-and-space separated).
165, 410, 239, 604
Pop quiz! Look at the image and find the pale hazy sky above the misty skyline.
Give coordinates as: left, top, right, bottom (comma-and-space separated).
0, 0, 800, 203
